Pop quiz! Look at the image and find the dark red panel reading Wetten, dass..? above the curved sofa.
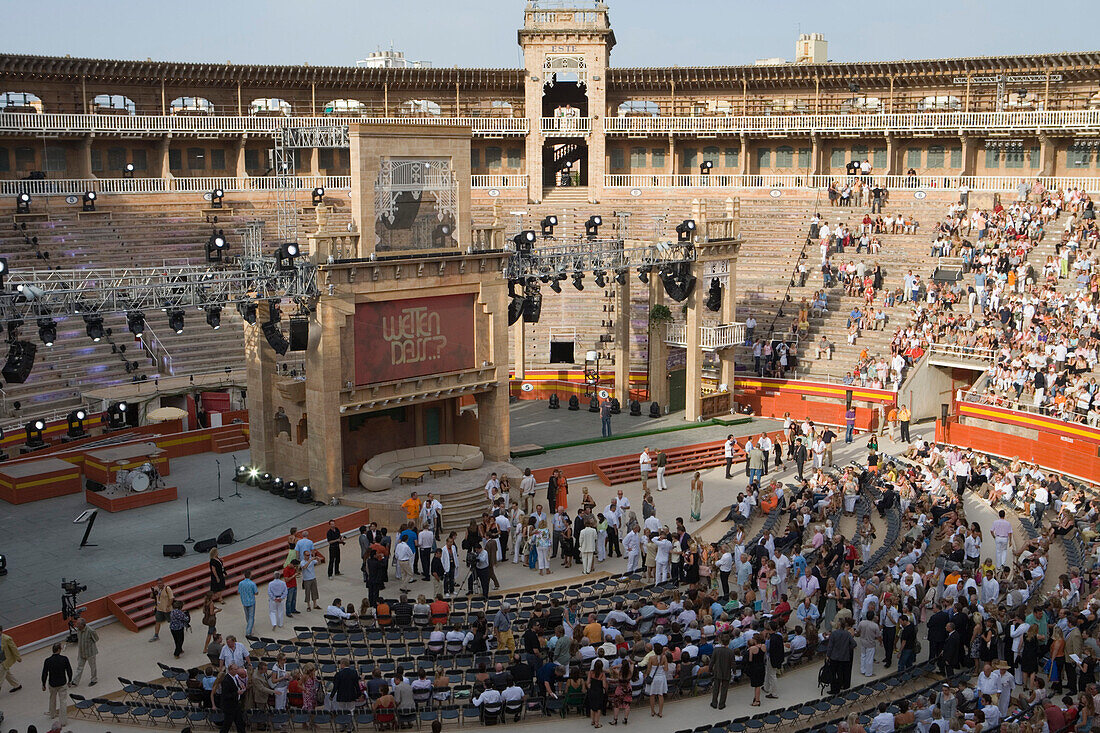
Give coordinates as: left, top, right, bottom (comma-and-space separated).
355, 293, 475, 384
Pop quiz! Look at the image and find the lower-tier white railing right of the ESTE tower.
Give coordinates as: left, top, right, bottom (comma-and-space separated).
604, 173, 1100, 193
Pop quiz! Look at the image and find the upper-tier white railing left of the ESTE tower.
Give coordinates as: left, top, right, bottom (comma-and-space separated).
0, 112, 529, 136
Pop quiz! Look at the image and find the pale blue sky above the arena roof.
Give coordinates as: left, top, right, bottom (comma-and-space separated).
0, 0, 1100, 67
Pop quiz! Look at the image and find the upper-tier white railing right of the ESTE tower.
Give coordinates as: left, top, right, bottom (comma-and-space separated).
604, 109, 1100, 134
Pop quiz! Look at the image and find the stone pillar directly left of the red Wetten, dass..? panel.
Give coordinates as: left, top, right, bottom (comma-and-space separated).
305, 298, 354, 502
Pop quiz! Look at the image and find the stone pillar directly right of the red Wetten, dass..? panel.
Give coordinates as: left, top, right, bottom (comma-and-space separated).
476, 281, 512, 461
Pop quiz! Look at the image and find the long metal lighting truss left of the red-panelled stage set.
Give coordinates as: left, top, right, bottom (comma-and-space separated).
0, 220, 317, 324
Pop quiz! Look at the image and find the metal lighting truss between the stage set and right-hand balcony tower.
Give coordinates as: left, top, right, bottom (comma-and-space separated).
504, 234, 696, 281
